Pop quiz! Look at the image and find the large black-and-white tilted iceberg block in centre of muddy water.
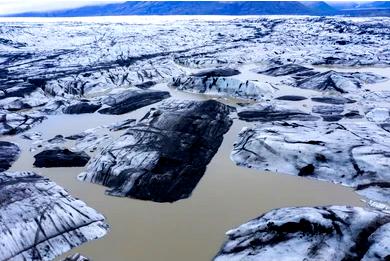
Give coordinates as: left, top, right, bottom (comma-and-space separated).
79, 100, 232, 202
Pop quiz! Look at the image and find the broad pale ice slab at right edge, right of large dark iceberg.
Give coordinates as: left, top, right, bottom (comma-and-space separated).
231, 121, 390, 204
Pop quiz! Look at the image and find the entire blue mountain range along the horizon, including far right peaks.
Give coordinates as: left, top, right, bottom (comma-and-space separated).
3, 1, 390, 17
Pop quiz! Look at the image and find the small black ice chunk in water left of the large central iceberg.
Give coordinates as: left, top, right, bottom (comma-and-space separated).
34, 149, 90, 168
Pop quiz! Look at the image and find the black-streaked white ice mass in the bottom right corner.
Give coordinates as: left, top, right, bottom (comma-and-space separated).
214, 206, 390, 261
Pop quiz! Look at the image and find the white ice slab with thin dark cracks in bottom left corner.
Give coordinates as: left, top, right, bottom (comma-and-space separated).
0, 172, 108, 260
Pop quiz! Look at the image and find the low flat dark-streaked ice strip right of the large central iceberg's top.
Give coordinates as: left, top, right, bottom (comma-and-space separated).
237, 104, 319, 122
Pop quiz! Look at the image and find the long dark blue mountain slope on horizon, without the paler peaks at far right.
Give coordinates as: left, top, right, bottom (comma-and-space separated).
8, 1, 314, 17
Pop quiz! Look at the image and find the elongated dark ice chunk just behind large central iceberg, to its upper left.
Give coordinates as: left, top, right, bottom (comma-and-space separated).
98, 90, 170, 115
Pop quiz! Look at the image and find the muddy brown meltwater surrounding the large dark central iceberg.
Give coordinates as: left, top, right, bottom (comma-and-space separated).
3, 77, 363, 261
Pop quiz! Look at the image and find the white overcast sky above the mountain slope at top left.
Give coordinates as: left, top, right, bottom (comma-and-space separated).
0, 0, 374, 15
